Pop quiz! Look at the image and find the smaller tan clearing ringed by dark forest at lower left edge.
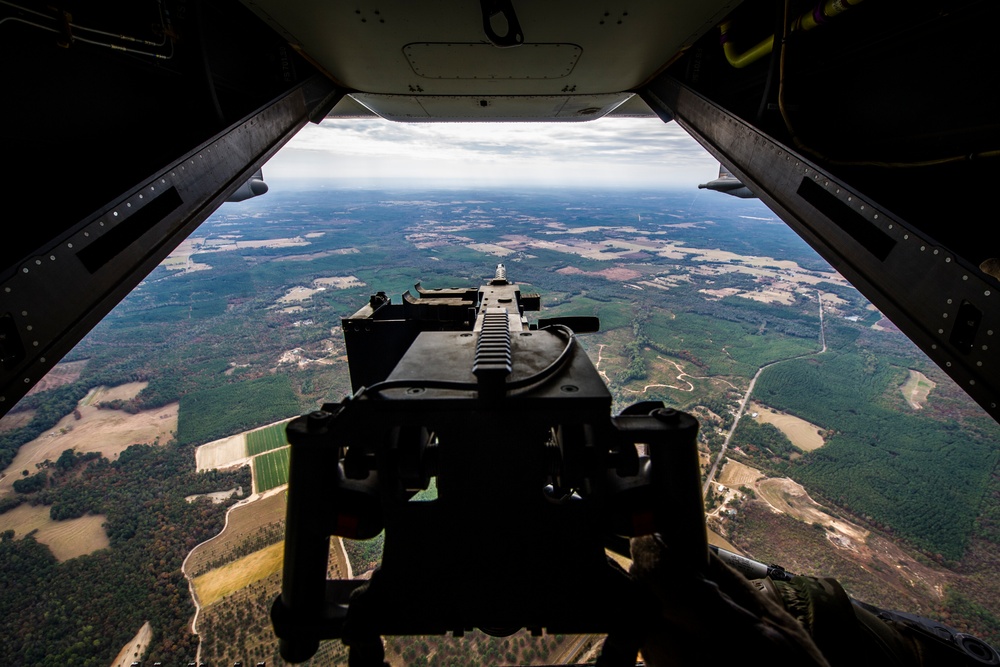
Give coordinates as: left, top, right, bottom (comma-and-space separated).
0, 503, 111, 562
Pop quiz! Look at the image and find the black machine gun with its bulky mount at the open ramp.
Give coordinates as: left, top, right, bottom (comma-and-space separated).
271, 264, 708, 665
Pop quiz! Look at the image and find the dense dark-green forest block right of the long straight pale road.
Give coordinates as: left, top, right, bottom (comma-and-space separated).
751, 342, 1000, 562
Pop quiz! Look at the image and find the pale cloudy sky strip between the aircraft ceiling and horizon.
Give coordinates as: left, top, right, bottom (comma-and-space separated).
264, 113, 719, 188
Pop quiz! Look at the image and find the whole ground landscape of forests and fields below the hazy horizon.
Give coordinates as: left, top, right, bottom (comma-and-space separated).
0, 188, 1000, 666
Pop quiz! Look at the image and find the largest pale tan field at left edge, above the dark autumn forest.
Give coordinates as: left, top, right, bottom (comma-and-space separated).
0, 392, 177, 495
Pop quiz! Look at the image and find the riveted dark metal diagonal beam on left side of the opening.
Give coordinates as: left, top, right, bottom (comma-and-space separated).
0, 76, 340, 416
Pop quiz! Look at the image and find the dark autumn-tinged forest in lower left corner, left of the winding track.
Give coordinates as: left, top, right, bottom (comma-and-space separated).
0, 444, 250, 667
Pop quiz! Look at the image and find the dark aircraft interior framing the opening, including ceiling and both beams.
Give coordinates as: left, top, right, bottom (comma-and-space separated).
0, 0, 1000, 418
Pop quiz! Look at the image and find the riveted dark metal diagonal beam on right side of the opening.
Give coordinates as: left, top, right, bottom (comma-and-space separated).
642, 76, 1000, 420
